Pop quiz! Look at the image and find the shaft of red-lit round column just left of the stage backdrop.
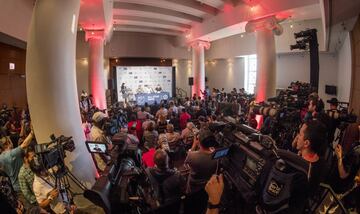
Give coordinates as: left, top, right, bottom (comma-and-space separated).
88, 37, 106, 109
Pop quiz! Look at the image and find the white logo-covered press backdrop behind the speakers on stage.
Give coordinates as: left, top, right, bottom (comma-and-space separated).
116, 66, 174, 101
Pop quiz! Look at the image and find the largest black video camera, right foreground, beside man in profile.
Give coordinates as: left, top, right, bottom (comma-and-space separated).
209, 119, 308, 213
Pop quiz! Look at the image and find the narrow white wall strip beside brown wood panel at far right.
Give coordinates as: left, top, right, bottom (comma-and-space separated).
337, 33, 352, 102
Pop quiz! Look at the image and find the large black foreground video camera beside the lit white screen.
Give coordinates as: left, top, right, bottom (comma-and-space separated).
84, 136, 148, 213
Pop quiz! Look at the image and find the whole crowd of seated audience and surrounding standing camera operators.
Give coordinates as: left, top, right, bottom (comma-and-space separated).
0, 84, 360, 213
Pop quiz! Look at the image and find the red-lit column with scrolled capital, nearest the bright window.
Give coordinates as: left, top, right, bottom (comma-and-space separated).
245, 16, 282, 102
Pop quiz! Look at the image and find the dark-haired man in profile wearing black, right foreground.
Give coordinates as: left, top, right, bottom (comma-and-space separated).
293, 120, 328, 196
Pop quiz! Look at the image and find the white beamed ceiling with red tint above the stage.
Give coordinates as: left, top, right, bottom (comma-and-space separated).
113, 0, 321, 41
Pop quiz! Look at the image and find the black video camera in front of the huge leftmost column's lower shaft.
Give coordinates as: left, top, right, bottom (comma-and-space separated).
35, 134, 75, 177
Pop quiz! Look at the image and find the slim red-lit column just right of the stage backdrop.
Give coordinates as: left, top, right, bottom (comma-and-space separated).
191, 40, 210, 97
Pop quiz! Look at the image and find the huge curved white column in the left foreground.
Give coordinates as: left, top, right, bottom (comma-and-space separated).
26, 0, 96, 187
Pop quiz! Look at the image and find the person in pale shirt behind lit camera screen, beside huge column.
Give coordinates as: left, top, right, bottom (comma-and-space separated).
90, 112, 112, 172
